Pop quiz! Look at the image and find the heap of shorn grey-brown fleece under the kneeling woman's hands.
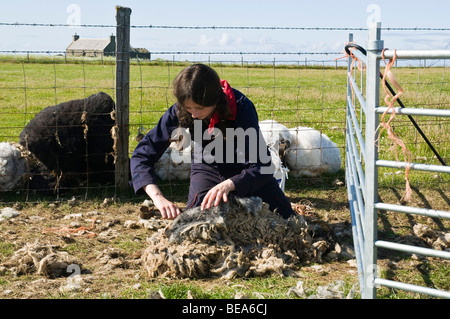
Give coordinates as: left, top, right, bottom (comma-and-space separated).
142, 197, 329, 279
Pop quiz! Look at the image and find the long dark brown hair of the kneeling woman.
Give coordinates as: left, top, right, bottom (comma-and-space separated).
173, 64, 230, 127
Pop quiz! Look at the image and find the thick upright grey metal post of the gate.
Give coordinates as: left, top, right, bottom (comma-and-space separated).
362, 22, 383, 299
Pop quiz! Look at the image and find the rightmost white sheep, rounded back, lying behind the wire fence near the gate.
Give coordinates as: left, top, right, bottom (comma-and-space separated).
286, 126, 341, 177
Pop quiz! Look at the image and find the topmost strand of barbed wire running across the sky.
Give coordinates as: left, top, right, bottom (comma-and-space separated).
0, 22, 450, 31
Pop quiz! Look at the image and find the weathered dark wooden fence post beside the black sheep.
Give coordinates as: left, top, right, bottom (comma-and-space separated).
115, 6, 131, 189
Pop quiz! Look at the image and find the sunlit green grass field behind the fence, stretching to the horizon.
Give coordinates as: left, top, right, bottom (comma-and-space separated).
0, 56, 450, 190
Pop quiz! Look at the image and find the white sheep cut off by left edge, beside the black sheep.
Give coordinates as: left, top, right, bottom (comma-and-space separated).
0, 142, 27, 191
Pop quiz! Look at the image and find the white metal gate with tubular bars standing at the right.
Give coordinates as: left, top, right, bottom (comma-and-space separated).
346, 23, 450, 299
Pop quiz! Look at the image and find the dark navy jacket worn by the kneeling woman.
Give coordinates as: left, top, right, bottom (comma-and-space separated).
130, 89, 274, 197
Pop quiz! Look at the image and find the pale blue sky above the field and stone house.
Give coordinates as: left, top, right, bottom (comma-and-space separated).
0, 0, 450, 60
